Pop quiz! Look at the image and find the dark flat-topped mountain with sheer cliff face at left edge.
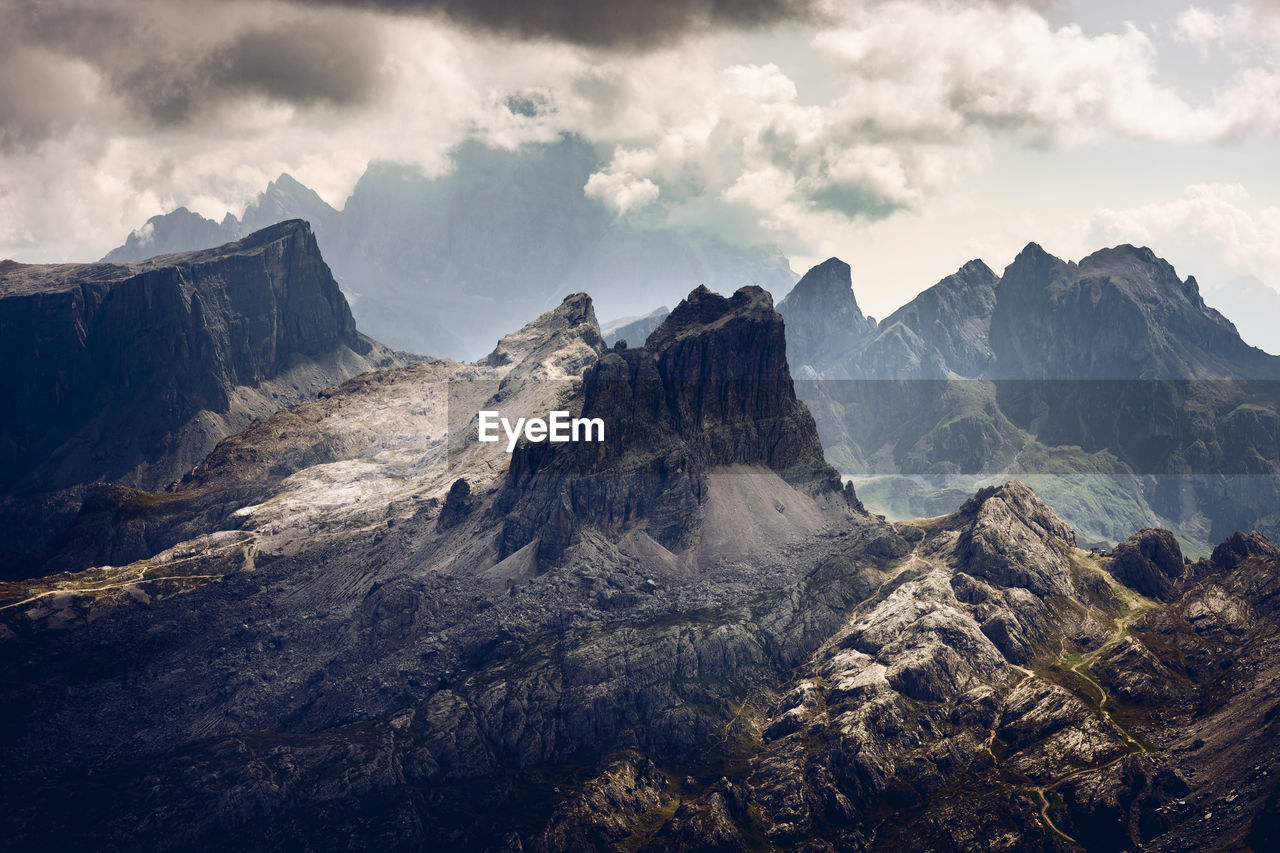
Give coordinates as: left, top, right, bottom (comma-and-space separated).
0, 222, 393, 578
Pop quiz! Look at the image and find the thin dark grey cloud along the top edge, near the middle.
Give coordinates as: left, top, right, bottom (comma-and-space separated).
294, 0, 817, 49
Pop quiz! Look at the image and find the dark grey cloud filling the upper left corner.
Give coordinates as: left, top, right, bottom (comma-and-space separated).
0, 0, 381, 149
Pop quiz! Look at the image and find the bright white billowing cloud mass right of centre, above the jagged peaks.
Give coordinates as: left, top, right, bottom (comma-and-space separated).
564, 0, 1213, 248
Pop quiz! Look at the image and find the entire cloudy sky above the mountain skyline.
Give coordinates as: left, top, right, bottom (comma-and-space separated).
0, 0, 1280, 316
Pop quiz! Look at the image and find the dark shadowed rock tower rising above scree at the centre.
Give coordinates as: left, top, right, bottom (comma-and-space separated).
499, 287, 841, 560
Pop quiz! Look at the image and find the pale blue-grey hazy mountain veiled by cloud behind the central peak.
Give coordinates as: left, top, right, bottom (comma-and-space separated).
108, 137, 795, 359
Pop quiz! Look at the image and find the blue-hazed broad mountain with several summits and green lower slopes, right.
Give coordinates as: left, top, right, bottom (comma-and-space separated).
787, 243, 1280, 546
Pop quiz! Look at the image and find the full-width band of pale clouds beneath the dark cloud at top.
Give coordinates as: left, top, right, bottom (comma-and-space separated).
0, 0, 1280, 267
